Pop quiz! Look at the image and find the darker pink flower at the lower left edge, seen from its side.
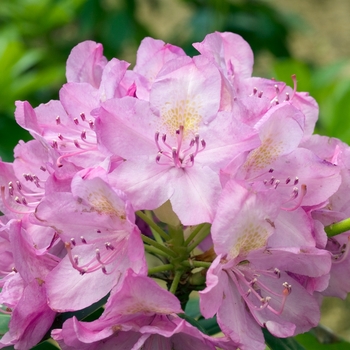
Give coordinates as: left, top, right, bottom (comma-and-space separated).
0, 220, 59, 349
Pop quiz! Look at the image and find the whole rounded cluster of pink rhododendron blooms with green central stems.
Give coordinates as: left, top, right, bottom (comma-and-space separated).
0, 33, 350, 350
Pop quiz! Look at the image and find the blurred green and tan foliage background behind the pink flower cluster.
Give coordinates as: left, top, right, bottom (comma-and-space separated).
0, 0, 350, 346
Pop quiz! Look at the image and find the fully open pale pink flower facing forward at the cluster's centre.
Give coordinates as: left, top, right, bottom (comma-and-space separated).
96, 56, 257, 225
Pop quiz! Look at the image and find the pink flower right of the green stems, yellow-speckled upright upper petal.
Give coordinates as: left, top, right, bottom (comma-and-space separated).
200, 180, 331, 349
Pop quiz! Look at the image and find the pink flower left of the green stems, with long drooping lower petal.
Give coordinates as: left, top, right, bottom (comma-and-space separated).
35, 169, 146, 311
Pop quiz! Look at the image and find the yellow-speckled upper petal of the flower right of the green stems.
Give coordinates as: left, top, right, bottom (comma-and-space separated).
212, 180, 278, 258
